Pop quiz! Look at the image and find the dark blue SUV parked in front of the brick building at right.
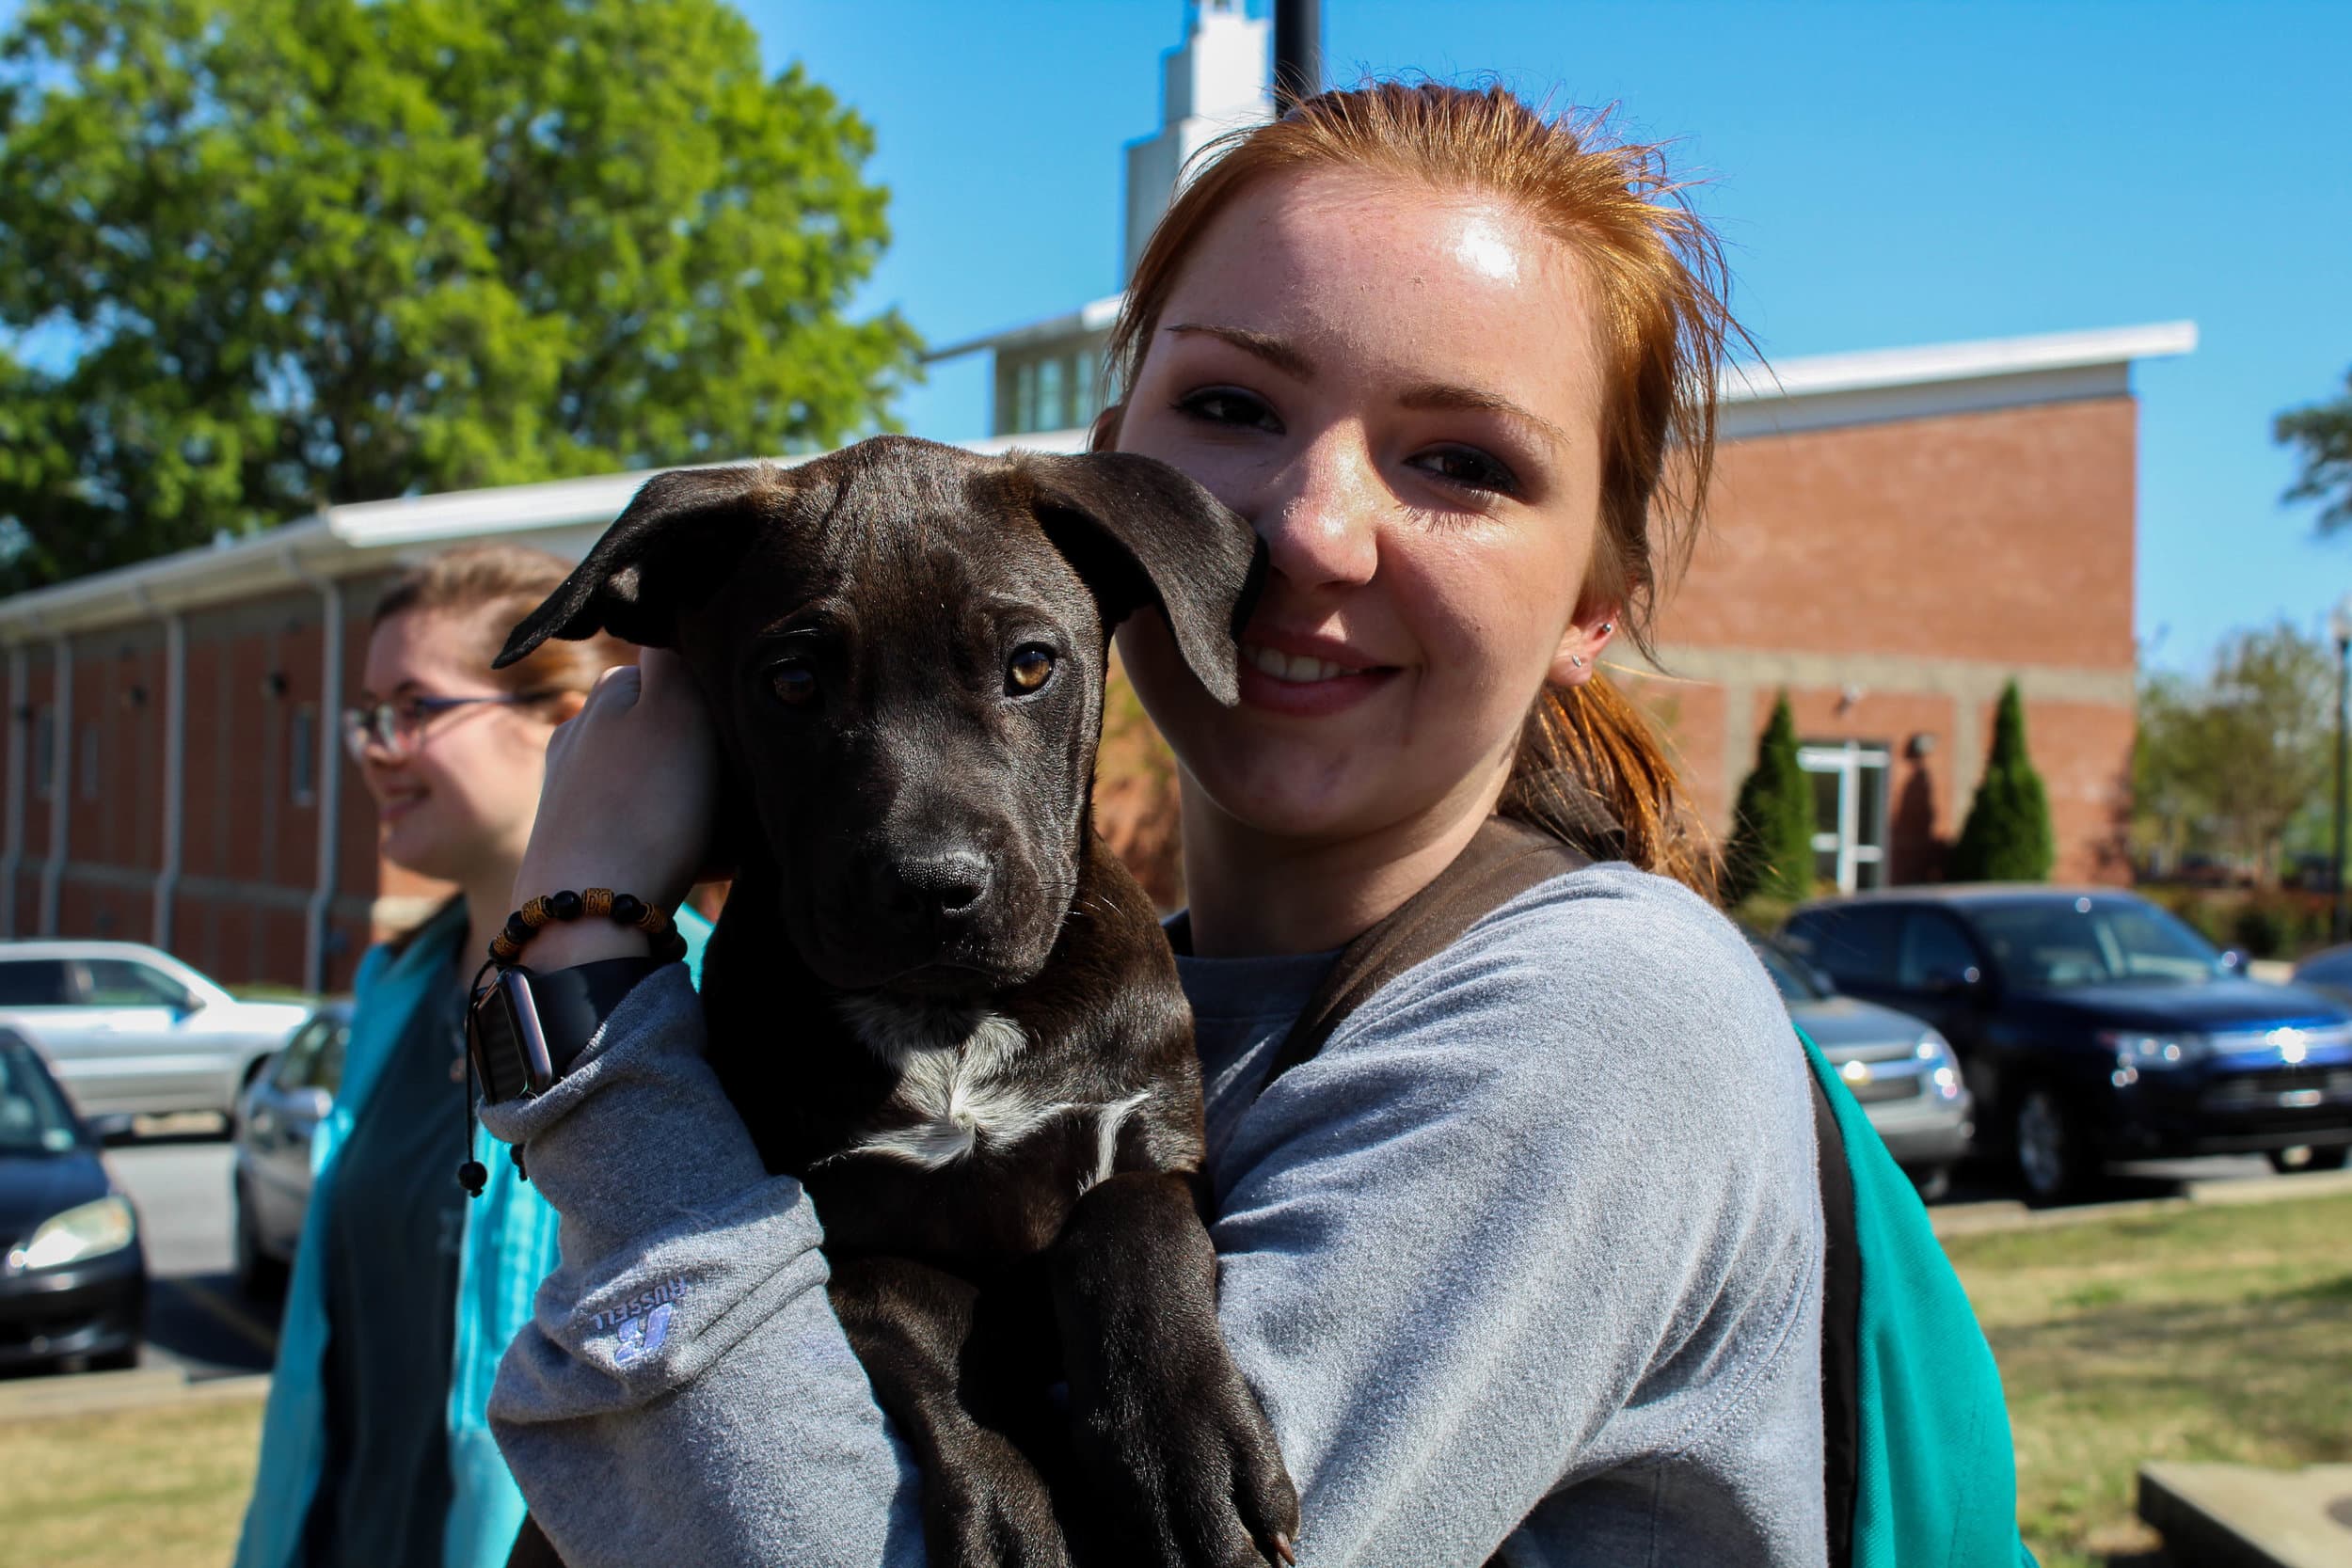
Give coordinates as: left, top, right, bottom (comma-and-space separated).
1783, 884, 2352, 1201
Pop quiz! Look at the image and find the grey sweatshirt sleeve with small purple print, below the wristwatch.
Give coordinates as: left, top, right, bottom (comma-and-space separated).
483, 964, 925, 1568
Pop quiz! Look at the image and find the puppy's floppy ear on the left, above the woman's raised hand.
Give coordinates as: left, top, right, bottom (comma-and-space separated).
492, 463, 793, 670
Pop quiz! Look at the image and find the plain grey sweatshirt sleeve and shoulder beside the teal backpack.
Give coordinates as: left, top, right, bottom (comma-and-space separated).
1214, 867, 1823, 1568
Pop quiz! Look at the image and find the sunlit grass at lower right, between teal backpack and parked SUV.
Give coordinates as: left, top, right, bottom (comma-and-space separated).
1946, 1196, 2352, 1568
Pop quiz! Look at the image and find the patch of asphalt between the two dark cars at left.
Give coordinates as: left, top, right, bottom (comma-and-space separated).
106, 1135, 278, 1378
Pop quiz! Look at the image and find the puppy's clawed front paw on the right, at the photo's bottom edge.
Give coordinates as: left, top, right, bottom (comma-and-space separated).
1077, 1347, 1298, 1568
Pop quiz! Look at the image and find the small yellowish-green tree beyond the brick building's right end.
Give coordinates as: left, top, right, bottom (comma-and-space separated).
2131, 621, 2336, 884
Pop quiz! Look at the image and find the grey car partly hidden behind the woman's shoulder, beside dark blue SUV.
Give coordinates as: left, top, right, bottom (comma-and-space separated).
1750, 938, 1976, 1201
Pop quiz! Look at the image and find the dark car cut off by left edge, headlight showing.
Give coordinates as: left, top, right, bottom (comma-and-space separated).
0, 1030, 149, 1369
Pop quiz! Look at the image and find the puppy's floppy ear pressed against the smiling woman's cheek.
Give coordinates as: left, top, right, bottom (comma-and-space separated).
1019, 451, 1265, 707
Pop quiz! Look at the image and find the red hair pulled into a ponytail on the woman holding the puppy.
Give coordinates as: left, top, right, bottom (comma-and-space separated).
1096, 82, 1745, 894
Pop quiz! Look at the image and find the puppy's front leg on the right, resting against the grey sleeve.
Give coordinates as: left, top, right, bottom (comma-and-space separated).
1054, 1171, 1298, 1568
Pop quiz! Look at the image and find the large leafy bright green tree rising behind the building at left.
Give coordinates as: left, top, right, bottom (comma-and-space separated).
0, 0, 915, 588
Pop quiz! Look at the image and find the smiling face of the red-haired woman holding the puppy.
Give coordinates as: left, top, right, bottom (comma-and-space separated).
1118, 174, 1609, 839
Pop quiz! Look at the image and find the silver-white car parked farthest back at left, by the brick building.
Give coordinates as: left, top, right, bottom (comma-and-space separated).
0, 941, 310, 1124
